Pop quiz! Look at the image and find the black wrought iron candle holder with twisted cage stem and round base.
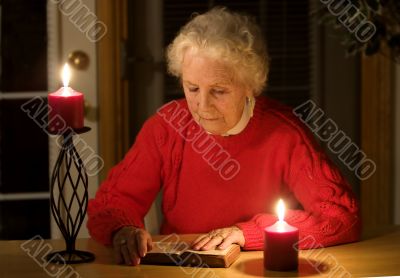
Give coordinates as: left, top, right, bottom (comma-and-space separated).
46, 127, 95, 264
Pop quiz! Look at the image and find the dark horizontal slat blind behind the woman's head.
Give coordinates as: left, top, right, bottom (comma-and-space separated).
163, 0, 312, 106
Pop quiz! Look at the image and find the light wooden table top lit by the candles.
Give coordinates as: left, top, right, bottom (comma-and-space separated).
0, 228, 400, 278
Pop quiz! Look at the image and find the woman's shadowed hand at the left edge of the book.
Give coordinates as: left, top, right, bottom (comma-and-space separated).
113, 226, 153, 266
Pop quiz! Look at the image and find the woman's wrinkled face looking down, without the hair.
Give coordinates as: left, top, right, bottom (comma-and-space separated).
182, 51, 251, 135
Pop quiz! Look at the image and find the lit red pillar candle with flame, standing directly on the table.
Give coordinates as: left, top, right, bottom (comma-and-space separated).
264, 200, 299, 271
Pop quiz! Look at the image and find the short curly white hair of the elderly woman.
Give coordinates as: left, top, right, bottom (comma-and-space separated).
166, 7, 269, 96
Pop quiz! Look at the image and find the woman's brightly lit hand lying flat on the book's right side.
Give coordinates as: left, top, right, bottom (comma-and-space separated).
191, 226, 245, 250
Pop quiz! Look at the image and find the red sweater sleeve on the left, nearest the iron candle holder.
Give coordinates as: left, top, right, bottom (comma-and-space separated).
87, 117, 165, 245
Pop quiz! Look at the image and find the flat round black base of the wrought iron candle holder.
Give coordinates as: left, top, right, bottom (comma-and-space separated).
46, 250, 95, 264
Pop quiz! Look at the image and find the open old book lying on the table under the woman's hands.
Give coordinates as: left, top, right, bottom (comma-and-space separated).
141, 241, 240, 267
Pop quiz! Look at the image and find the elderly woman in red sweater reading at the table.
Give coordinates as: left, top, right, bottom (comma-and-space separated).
88, 8, 360, 265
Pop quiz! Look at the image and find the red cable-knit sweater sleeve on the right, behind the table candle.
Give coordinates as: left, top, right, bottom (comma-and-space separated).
236, 121, 361, 250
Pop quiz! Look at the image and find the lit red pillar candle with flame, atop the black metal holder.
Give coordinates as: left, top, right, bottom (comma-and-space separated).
48, 64, 84, 133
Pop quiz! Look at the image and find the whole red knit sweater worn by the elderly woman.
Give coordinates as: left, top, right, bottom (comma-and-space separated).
88, 97, 360, 250
